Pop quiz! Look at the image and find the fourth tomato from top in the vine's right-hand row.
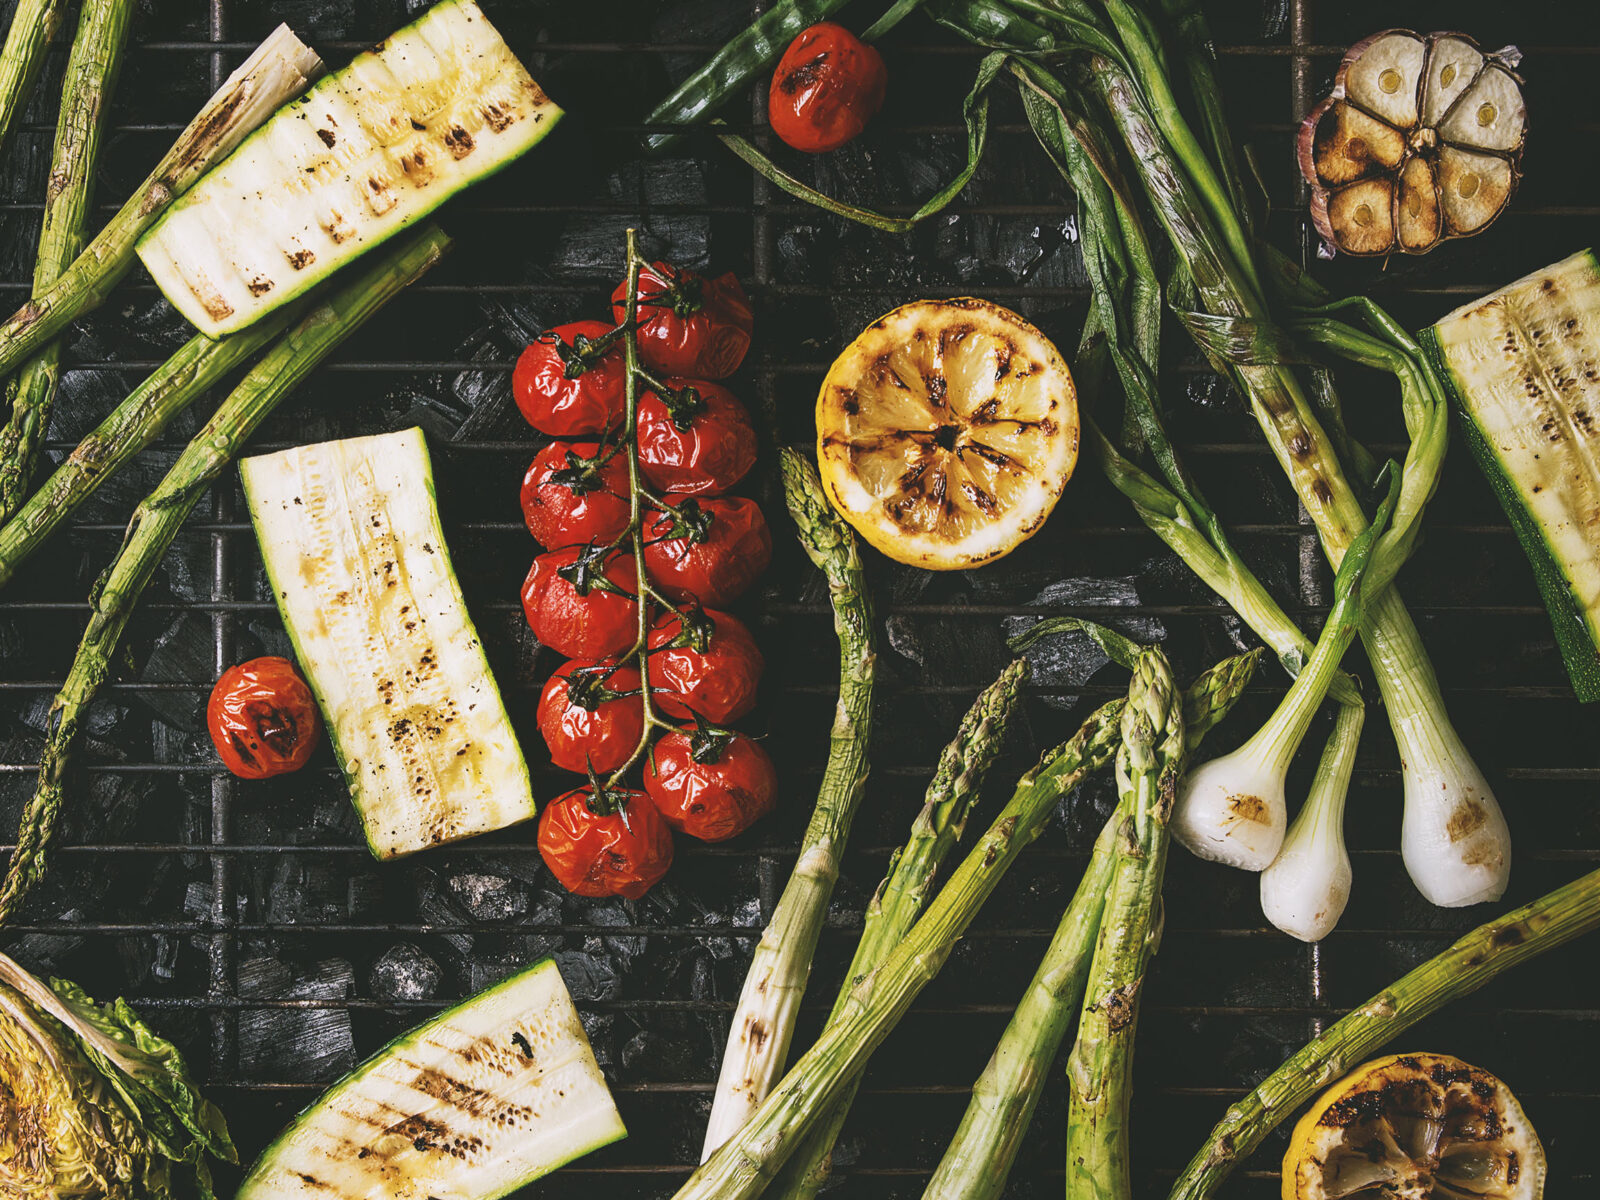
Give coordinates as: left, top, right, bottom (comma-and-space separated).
650, 608, 765, 725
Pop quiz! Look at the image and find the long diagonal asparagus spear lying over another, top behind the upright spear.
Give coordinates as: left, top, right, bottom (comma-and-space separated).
677, 652, 1248, 1200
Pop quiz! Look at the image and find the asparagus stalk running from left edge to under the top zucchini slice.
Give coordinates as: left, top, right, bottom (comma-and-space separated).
0, 310, 309, 587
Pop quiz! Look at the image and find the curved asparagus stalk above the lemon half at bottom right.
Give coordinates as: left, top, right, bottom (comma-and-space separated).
1170, 870, 1600, 1200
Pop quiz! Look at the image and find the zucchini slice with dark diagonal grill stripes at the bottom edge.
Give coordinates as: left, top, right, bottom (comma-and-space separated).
237, 958, 627, 1200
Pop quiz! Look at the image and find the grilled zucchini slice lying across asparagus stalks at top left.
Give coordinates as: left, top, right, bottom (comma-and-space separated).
139, 0, 562, 338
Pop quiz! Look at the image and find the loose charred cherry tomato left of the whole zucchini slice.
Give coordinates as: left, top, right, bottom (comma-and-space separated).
205, 654, 322, 779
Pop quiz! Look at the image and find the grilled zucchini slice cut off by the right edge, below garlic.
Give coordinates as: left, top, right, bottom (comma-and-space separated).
1422, 250, 1600, 702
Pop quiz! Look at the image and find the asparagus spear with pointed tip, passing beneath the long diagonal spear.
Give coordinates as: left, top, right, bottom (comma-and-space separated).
766, 659, 1027, 1200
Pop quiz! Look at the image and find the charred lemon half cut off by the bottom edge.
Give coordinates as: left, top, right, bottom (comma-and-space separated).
1283, 1054, 1544, 1200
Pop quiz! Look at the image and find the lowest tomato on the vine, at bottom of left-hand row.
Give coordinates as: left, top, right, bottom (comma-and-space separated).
539, 784, 672, 899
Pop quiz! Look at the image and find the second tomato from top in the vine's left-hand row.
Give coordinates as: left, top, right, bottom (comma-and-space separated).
522, 442, 629, 550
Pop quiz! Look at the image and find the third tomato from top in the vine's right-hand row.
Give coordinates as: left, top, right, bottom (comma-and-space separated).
645, 496, 773, 608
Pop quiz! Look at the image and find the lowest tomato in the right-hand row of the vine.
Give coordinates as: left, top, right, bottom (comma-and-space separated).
645, 726, 778, 842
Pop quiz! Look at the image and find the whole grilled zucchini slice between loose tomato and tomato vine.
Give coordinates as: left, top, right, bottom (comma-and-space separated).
240, 429, 536, 859
